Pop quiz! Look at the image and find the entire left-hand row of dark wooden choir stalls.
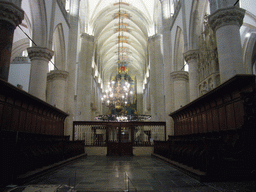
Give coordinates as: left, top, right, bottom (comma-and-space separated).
0, 79, 70, 186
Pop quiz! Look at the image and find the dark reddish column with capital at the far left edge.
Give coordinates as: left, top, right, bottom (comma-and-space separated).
0, 0, 24, 81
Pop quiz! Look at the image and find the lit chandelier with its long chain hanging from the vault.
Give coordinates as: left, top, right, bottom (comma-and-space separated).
102, 0, 136, 113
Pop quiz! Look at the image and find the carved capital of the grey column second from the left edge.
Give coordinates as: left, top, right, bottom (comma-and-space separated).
27, 47, 54, 62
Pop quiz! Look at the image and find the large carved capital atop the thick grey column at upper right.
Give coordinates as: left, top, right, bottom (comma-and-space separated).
209, 7, 245, 31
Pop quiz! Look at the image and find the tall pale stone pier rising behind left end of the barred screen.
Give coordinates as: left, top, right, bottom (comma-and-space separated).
77, 33, 94, 121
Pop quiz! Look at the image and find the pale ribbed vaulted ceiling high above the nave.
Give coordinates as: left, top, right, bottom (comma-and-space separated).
89, 0, 155, 87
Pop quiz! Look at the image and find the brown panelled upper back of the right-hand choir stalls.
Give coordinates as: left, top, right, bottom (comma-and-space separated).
170, 75, 256, 135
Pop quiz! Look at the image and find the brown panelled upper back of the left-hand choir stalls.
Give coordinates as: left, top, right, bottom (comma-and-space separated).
0, 80, 68, 135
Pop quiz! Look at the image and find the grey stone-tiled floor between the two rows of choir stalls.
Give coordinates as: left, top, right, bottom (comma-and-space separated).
4, 156, 256, 192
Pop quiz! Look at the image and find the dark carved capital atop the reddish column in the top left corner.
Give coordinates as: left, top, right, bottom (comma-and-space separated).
0, 2, 24, 27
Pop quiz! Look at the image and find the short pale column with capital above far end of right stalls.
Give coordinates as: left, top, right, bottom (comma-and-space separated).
171, 71, 188, 110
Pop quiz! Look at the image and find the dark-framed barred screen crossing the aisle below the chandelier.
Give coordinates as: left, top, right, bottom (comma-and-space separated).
73, 121, 166, 146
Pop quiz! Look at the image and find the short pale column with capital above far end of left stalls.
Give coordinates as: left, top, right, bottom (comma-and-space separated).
47, 70, 68, 111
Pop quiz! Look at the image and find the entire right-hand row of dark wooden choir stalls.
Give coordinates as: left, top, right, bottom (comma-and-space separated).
155, 75, 256, 179
